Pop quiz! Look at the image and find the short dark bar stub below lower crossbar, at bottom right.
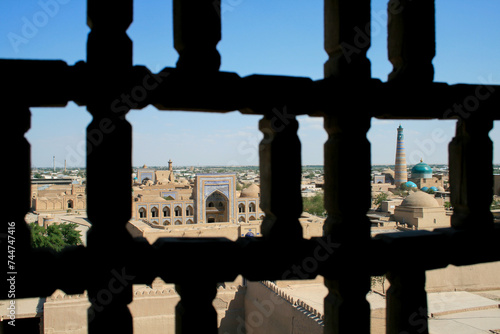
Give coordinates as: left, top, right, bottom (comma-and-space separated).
386, 269, 429, 334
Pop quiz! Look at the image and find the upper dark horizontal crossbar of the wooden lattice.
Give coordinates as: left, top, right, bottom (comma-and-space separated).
0, 59, 500, 120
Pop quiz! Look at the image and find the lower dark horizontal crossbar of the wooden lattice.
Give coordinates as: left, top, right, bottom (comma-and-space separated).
8, 224, 500, 298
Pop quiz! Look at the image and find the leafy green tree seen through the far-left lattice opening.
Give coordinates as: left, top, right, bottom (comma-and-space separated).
30, 223, 82, 252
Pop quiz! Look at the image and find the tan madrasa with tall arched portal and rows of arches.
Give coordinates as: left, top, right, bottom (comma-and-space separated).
129, 161, 265, 239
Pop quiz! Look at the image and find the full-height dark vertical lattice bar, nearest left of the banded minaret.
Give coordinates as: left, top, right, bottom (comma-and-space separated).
324, 0, 371, 333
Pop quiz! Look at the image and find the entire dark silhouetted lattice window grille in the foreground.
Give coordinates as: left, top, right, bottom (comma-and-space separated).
0, 0, 500, 333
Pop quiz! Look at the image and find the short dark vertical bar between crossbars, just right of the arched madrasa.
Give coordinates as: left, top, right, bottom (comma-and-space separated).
259, 111, 302, 242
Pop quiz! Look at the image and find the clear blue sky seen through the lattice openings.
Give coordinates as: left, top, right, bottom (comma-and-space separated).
0, 0, 500, 167
